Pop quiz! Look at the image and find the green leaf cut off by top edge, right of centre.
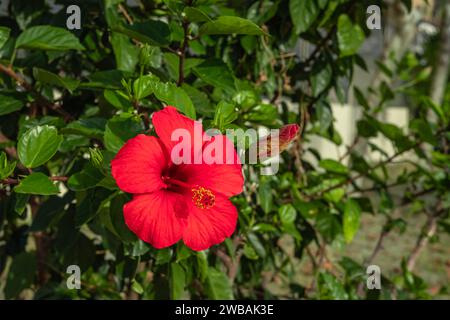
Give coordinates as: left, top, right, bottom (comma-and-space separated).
289, 0, 320, 35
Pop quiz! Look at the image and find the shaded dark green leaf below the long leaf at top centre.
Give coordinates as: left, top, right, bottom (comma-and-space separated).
193, 60, 236, 93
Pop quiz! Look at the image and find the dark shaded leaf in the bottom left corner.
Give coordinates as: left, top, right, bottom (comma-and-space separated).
5, 252, 37, 299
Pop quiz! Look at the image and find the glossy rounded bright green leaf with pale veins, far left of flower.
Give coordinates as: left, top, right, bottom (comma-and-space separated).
17, 125, 63, 168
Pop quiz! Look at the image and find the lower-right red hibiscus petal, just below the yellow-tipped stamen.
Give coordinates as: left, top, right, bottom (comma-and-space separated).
183, 195, 238, 251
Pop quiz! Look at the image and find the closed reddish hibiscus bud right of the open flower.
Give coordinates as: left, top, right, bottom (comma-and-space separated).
256, 124, 300, 161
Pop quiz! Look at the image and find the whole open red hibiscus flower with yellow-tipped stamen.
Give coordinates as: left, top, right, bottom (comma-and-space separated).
111, 107, 244, 251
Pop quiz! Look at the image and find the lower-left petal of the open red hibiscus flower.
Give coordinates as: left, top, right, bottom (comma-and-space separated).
123, 190, 186, 249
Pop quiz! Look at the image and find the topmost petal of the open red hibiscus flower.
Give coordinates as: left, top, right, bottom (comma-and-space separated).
152, 106, 203, 154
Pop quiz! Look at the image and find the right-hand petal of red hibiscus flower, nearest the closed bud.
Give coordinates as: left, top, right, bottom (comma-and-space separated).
174, 135, 244, 197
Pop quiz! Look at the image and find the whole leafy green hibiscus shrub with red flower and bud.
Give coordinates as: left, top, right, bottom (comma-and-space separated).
0, 0, 450, 299
